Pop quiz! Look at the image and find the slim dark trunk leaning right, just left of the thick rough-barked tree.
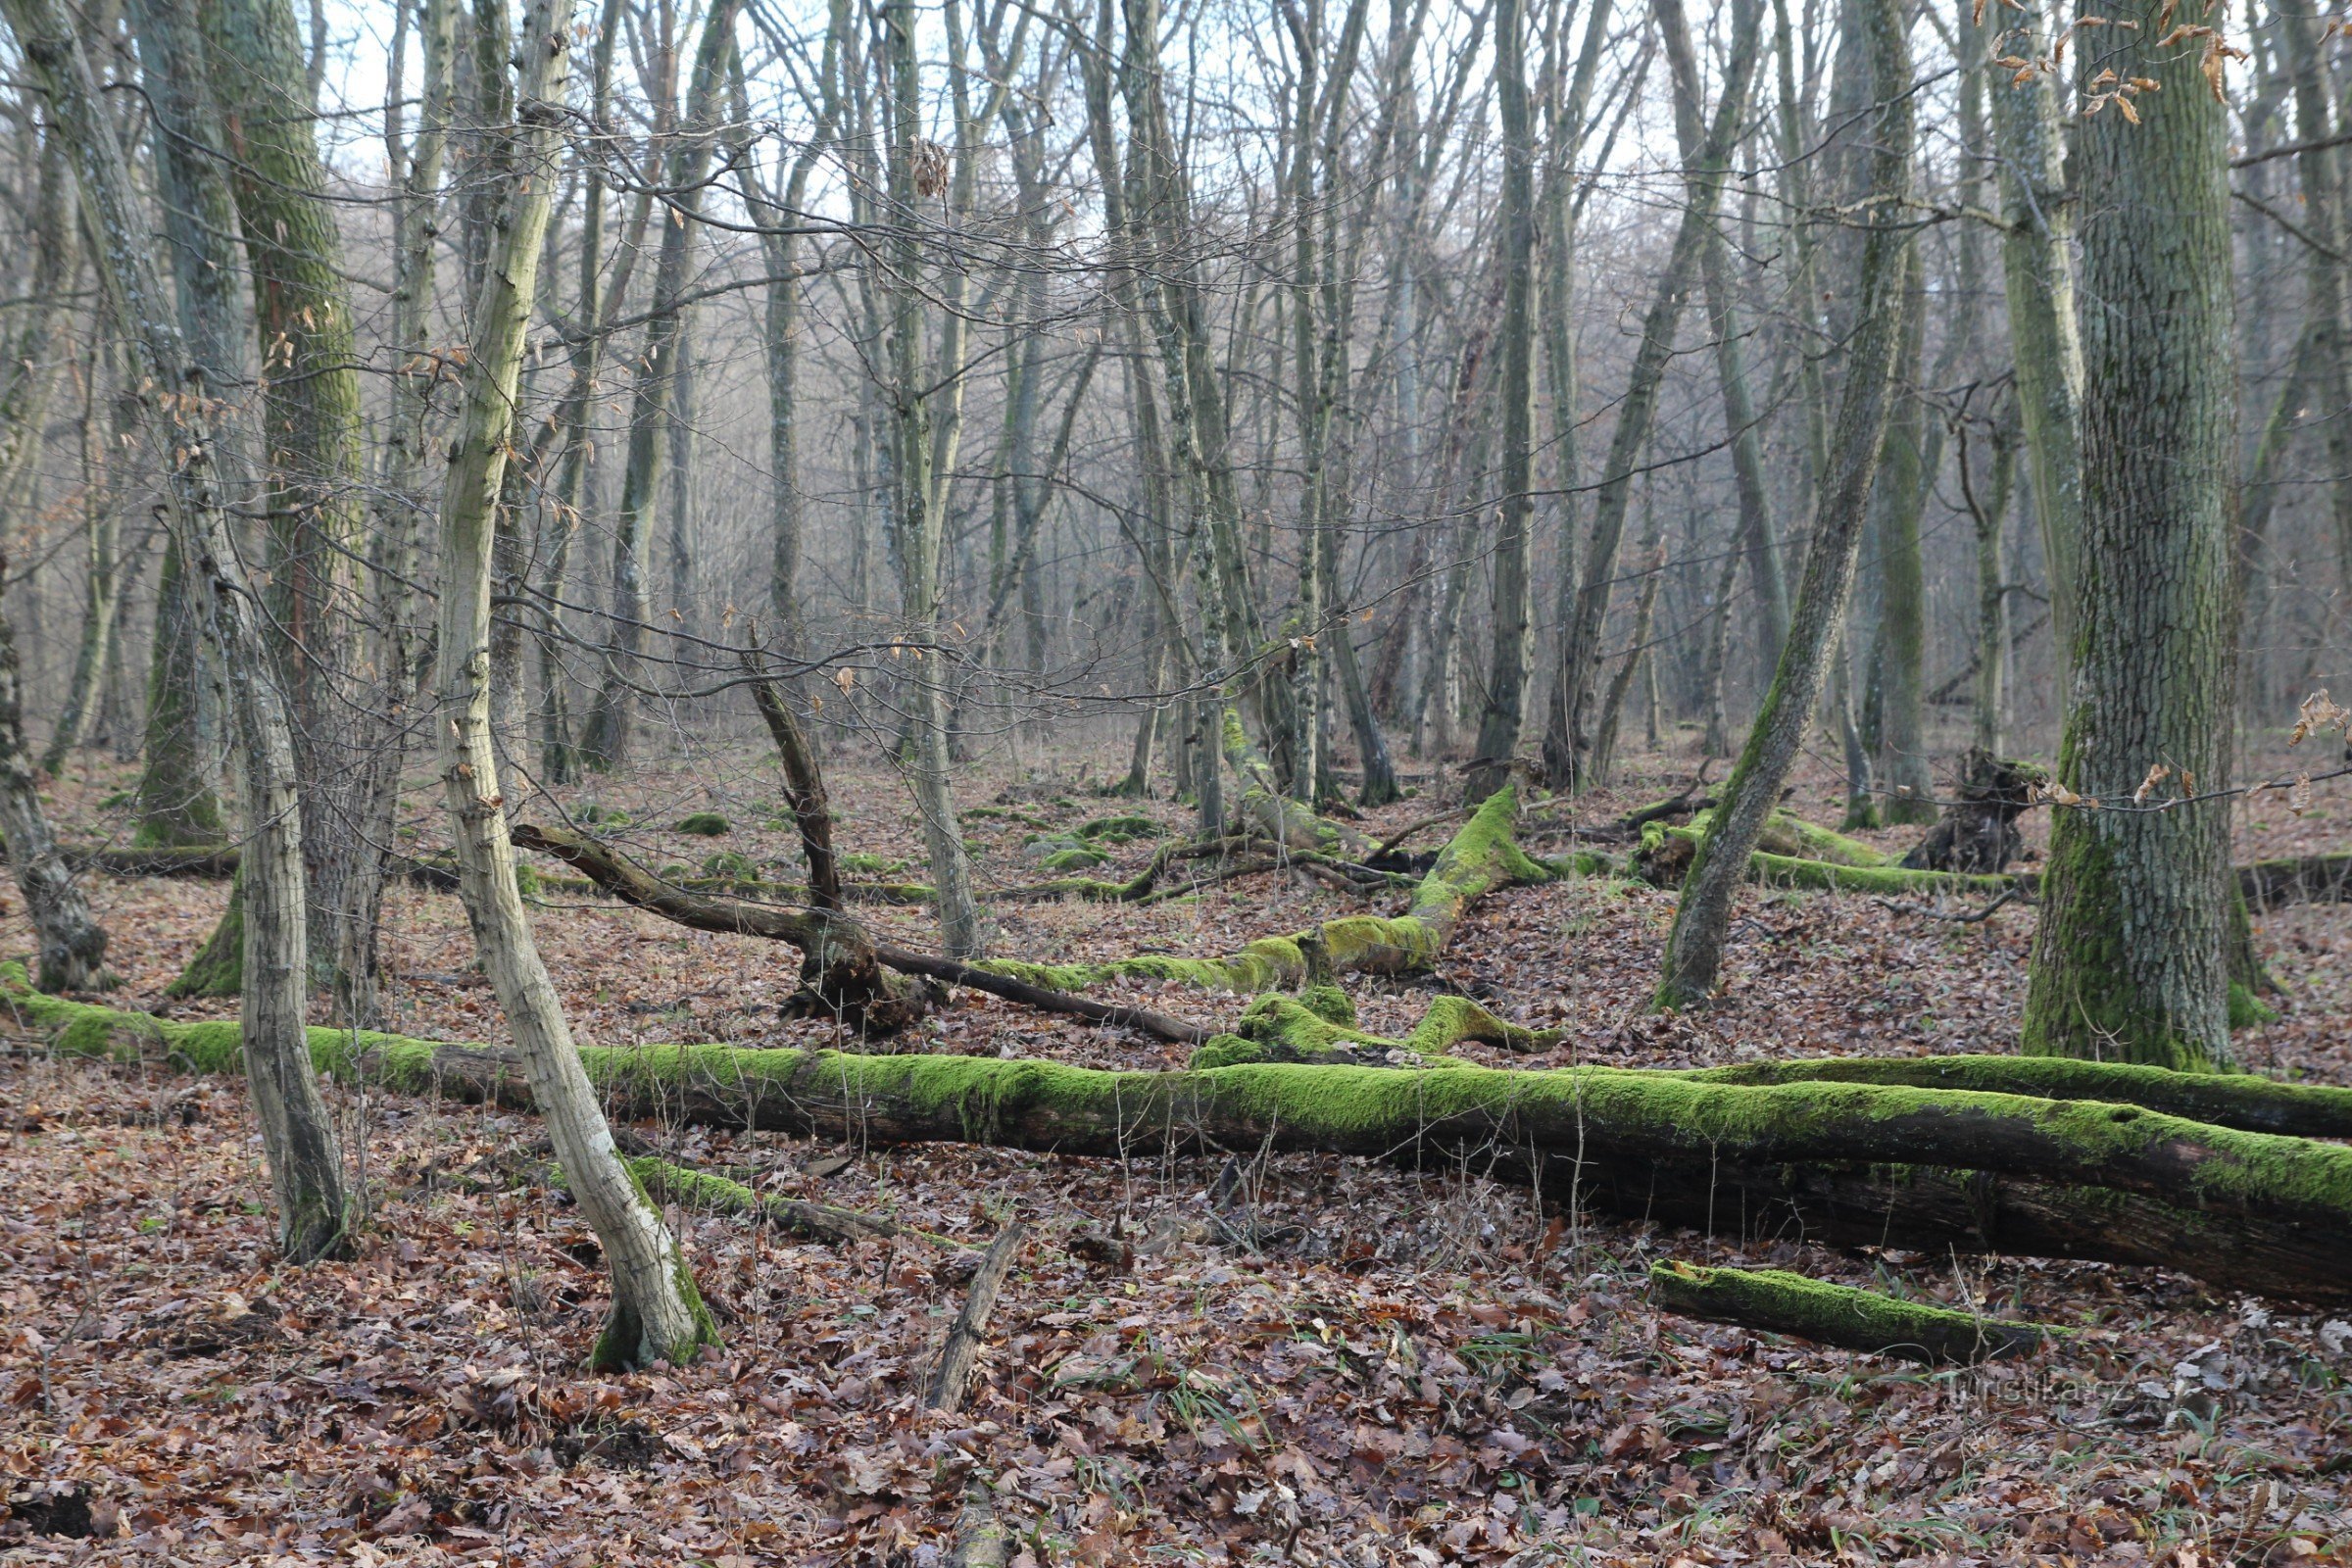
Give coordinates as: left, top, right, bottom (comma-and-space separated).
1658, 0, 1912, 1006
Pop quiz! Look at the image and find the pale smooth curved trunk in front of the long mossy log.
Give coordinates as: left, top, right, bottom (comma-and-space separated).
435, 0, 724, 1368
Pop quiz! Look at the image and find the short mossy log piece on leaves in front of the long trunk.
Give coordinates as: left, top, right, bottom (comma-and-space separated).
1648, 1262, 2060, 1366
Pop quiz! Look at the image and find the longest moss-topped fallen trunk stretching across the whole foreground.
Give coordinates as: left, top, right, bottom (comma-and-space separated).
18, 966, 2352, 1304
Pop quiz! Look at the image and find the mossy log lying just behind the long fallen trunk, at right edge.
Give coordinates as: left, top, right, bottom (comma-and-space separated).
1689, 1055, 2352, 1138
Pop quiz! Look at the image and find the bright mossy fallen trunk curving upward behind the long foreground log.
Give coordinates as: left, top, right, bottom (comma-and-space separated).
983, 785, 1557, 995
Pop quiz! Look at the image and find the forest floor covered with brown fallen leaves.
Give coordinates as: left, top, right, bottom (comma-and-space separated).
0, 741, 2352, 1568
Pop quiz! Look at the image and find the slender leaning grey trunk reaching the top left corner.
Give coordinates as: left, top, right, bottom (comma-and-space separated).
0, 0, 348, 1262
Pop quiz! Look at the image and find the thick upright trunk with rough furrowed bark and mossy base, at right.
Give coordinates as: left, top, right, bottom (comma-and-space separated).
2025, 0, 2236, 1067
